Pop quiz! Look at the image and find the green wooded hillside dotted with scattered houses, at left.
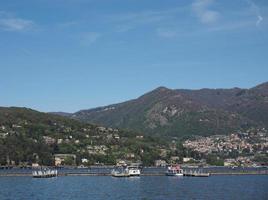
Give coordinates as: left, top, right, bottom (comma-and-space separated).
0, 107, 172, 165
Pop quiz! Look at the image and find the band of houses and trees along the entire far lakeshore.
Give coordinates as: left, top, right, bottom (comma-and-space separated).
0, 117, 268, 167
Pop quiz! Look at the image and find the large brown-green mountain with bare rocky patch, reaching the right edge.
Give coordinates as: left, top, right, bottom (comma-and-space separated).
71, 82, 268, 136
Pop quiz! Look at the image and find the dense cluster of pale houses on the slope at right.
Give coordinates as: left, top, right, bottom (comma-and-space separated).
183, 128, 268, 166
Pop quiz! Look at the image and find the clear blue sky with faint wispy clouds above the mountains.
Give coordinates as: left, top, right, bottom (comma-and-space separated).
0, 0, 268, 112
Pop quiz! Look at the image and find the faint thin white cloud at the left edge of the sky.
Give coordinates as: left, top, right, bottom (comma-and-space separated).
0, 11, 34, 31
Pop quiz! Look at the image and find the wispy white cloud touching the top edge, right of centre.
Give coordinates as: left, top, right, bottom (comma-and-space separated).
192, 0, 220, 24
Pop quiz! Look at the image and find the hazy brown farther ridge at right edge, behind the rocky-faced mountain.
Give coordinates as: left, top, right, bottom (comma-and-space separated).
179, 82, 268, 127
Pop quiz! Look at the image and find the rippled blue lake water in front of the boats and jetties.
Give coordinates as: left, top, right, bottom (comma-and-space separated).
0, 175, 268, 200
